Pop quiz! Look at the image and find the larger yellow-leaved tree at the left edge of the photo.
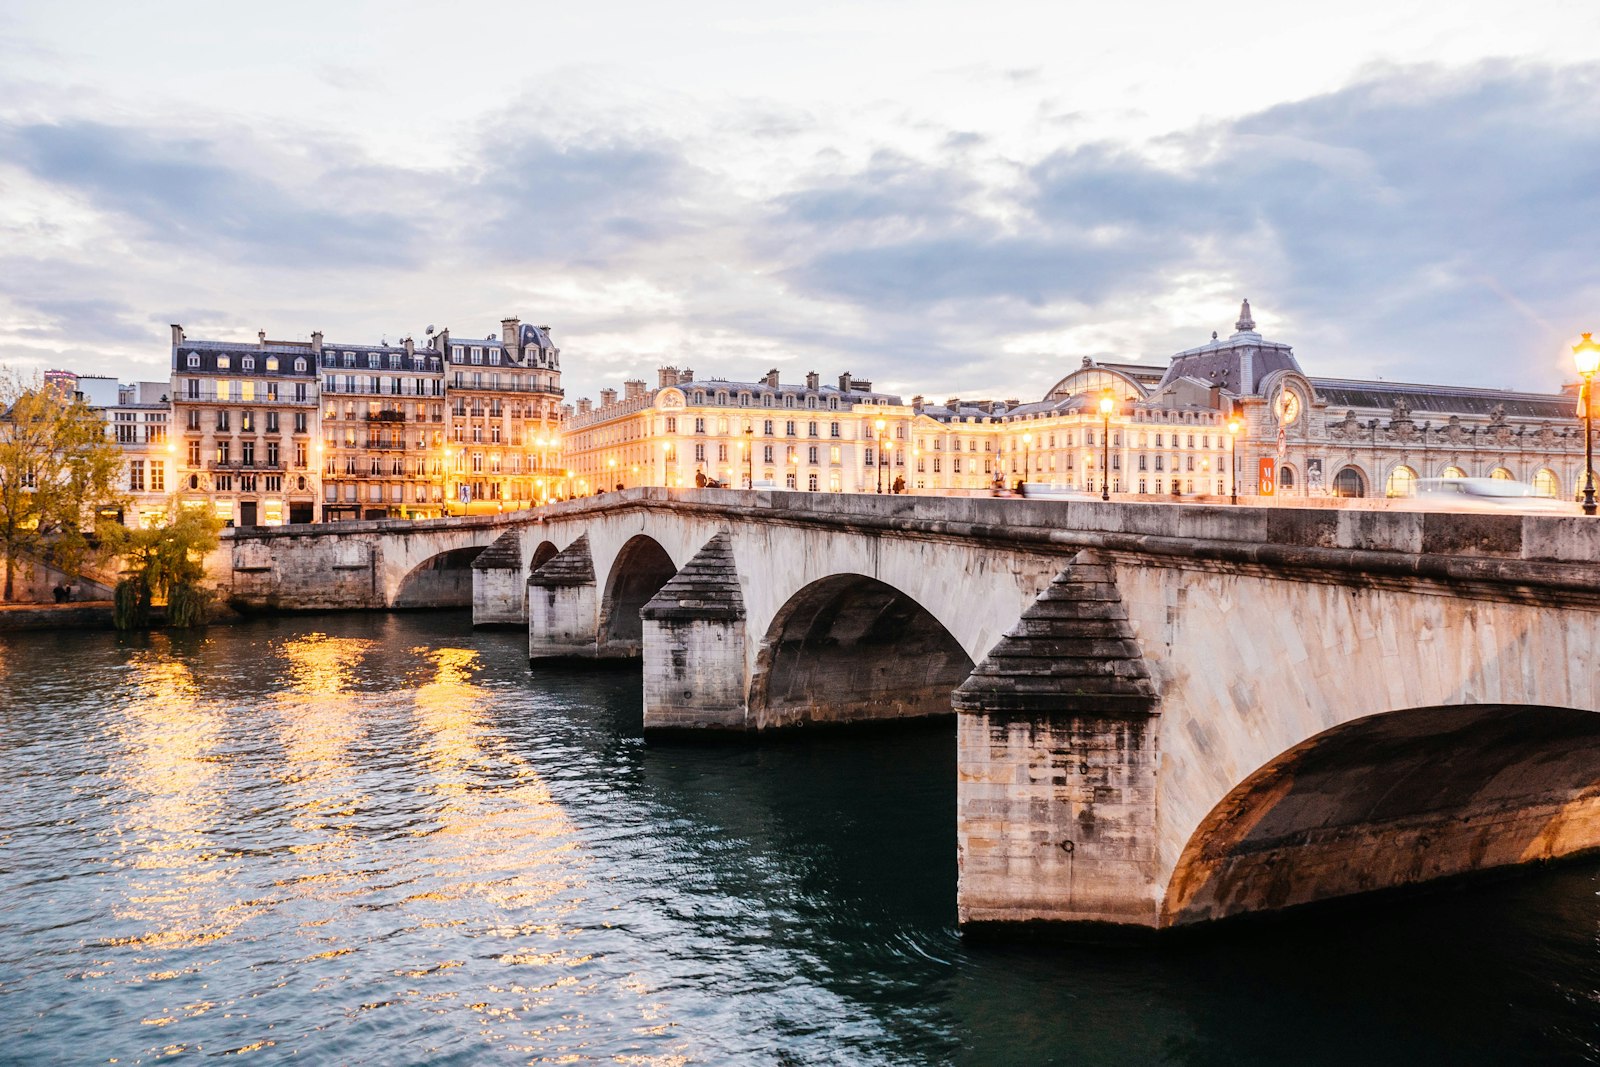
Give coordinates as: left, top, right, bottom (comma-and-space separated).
0, 373, 122, 600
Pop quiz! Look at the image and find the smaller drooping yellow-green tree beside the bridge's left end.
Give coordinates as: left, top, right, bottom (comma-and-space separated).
104, 496, 222, 630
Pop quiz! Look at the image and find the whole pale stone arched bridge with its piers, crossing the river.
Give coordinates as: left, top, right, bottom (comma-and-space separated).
213, 490, 1600, 928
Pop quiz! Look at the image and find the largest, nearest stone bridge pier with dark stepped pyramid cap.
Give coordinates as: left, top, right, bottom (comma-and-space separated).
954, 552, 1162, 926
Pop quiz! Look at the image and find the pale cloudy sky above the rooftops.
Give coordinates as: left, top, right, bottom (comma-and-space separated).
0, 0, 1600, 404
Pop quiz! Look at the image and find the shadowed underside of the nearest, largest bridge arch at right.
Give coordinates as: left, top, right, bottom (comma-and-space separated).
1160, 704, 1600, 926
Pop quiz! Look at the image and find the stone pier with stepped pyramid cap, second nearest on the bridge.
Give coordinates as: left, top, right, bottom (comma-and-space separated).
640, 533, 749, 731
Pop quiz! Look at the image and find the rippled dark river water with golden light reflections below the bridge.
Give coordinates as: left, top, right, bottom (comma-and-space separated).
0, 616, 1600, 1065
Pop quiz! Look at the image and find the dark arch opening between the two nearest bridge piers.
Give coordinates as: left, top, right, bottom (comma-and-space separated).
749, 574, 973, 728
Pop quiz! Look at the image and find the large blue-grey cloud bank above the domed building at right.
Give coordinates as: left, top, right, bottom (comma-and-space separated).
758, 64, 1600, 387
